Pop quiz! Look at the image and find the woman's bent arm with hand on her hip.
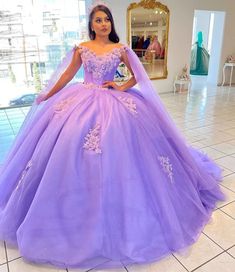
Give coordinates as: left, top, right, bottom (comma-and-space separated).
103, 47, 136, 92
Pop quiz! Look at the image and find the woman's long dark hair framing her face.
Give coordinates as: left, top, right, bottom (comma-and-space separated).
88, 5, 119, 43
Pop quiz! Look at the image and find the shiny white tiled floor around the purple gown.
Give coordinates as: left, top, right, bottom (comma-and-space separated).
0, 84, 235, 272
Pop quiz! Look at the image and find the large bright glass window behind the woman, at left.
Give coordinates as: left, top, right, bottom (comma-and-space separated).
0, 0, 90, 107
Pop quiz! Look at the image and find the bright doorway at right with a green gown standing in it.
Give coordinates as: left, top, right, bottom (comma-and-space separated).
190, 10, 225, 89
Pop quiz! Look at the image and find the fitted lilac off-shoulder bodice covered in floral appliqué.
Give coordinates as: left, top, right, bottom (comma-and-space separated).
78, 45, 127, 85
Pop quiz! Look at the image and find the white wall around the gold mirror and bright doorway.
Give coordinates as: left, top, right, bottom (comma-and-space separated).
106, 0, 235, 93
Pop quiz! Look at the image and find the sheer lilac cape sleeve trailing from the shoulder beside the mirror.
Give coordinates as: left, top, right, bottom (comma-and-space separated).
124, 46, 222, 183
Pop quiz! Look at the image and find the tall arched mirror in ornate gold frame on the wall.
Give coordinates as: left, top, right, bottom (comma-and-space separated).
127, 0, 170, 79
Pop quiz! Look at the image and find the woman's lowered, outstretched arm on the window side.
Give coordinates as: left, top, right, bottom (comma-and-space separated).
44, 47, 82, 100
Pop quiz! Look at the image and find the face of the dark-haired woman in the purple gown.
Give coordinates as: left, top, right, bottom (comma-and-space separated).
91, 11, 112, 36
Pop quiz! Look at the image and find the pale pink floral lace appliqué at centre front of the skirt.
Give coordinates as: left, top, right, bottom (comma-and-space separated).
83, 124, 102, 153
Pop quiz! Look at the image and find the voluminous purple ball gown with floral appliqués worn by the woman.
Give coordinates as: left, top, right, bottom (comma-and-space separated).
0, 46, 224, 268
